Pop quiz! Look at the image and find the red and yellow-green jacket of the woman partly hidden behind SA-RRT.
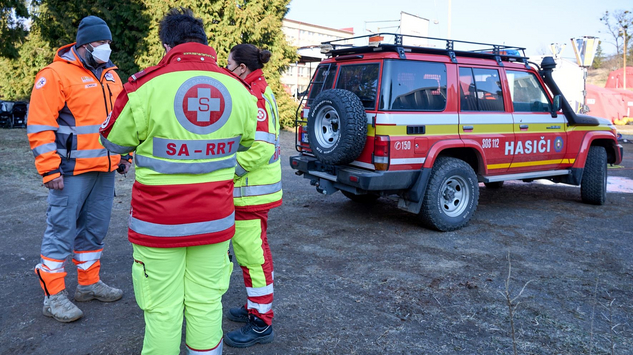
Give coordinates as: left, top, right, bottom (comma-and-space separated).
233, 69, 282, 211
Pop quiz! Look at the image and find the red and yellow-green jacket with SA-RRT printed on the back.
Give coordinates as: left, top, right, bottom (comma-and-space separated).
101, 43, 257, 248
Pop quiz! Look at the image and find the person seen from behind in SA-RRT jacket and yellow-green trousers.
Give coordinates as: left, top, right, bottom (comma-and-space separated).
101, 8, 257, 355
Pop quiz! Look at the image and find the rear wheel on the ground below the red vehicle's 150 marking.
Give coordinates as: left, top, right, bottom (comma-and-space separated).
420, 157, 479, 232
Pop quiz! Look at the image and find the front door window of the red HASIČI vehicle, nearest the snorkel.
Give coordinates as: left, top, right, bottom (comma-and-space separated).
506, 70, 551, 112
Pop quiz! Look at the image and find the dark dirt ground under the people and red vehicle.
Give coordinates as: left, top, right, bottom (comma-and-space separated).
0, 129, 633, 355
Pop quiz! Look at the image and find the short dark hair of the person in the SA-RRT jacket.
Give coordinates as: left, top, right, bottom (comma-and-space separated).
158, 7, 209, 48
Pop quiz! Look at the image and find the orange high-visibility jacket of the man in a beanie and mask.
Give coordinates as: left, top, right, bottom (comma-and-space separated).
26, 43, 123, 183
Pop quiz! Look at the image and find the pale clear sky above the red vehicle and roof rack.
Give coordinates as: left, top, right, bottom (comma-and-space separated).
286, 0, 633, 58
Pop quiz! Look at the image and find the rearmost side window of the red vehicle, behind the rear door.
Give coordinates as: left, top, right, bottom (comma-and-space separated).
380, 61, 446, 111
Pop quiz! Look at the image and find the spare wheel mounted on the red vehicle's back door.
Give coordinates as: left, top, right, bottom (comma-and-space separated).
308, 89, 367, 165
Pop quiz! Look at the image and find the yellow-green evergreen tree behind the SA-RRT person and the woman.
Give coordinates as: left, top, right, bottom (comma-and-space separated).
136, 0, 297, 127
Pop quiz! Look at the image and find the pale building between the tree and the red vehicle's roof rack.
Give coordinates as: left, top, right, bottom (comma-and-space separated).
281, 19, 354, 98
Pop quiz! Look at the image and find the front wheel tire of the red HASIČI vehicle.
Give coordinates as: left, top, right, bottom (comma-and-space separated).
580, 145, 607, 205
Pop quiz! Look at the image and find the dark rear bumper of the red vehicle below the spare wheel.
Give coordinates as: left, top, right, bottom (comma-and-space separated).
290, 155, 420, 191
